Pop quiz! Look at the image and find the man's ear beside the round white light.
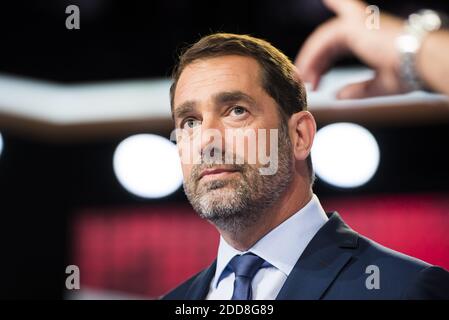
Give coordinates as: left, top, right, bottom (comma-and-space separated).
288, 111, 316, 160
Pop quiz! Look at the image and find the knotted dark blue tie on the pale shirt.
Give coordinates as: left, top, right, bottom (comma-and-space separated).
229, 253, 265, 300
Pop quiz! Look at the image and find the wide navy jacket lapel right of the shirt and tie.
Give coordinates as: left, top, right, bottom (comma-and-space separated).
276, 212, 358, 300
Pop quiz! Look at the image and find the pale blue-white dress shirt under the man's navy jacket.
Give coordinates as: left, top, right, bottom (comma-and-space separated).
206, 194, 328, 300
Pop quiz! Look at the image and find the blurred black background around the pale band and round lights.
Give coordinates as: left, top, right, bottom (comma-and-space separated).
0, 0, 449, 298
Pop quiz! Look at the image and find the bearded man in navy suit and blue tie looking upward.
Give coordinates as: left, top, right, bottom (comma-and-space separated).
164, 34, 449, 300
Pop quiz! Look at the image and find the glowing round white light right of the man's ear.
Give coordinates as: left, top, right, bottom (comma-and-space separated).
312, 122, 380, 188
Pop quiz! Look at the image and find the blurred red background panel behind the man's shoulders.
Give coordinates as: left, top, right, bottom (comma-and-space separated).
73, 194, 449, 297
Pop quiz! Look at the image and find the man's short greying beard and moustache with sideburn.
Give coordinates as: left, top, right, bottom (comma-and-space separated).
184, 124, 293, 234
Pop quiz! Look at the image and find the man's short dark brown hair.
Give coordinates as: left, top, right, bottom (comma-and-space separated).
170, 33, 314, 183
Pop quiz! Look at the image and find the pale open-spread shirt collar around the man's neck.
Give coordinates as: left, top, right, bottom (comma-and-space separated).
212, 194, 328, 288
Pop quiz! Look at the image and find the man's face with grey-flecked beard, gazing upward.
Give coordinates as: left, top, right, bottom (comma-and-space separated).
173, 55, 293, 227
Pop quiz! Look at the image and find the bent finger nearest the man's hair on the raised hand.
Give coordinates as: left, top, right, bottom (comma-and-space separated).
295, 19, 348, 90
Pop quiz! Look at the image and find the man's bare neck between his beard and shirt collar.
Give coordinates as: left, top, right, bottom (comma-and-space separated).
218, 183, 313, 251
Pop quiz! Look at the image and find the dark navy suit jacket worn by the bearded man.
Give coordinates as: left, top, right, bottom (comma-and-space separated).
163, 212, 449, 300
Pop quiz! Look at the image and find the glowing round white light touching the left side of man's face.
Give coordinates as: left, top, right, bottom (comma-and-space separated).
113, 134, 182, 198
